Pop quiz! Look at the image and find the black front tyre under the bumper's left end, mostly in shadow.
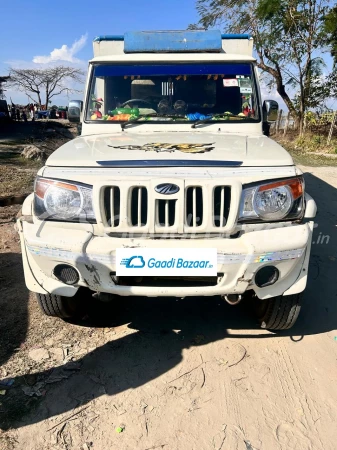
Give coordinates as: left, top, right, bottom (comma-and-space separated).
36, 294, 79, 319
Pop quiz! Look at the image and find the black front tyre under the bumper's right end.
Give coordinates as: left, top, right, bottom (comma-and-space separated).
255, 294, 301, 330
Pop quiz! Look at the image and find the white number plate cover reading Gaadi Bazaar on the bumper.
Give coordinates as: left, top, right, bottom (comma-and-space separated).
116, 248, 217, 277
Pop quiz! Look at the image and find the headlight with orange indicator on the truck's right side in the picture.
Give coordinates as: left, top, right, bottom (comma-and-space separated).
239, 177, 304, 222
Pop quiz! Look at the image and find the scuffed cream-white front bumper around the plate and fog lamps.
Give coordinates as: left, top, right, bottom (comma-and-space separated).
18, 218, 313, 299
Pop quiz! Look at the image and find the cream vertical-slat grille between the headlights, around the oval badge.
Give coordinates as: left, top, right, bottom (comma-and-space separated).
101, 179, 235, 235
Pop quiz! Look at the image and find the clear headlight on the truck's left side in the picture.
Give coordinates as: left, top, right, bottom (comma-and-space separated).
34, 177, 96, 222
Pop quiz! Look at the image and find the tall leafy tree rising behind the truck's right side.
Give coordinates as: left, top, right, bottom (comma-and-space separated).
190, 0, 330, 133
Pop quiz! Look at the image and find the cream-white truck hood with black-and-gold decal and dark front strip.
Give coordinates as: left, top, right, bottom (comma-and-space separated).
46, 132, 294, 167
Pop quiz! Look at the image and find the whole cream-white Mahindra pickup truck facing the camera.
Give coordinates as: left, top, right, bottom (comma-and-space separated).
18, 30, 316, 330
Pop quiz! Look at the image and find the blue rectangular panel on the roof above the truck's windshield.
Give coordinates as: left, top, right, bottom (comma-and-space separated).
124, 30, 222, 53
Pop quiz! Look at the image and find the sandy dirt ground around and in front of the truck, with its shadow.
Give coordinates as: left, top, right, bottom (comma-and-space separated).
0, 133, 337, 450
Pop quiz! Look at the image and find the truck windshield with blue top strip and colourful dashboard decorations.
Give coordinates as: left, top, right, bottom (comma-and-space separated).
86, 63, 260, 123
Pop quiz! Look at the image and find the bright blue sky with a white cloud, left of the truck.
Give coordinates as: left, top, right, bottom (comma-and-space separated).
0, 0, 283, 107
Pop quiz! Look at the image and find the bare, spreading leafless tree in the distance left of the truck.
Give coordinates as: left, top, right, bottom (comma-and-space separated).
9, 66, 84, 108
